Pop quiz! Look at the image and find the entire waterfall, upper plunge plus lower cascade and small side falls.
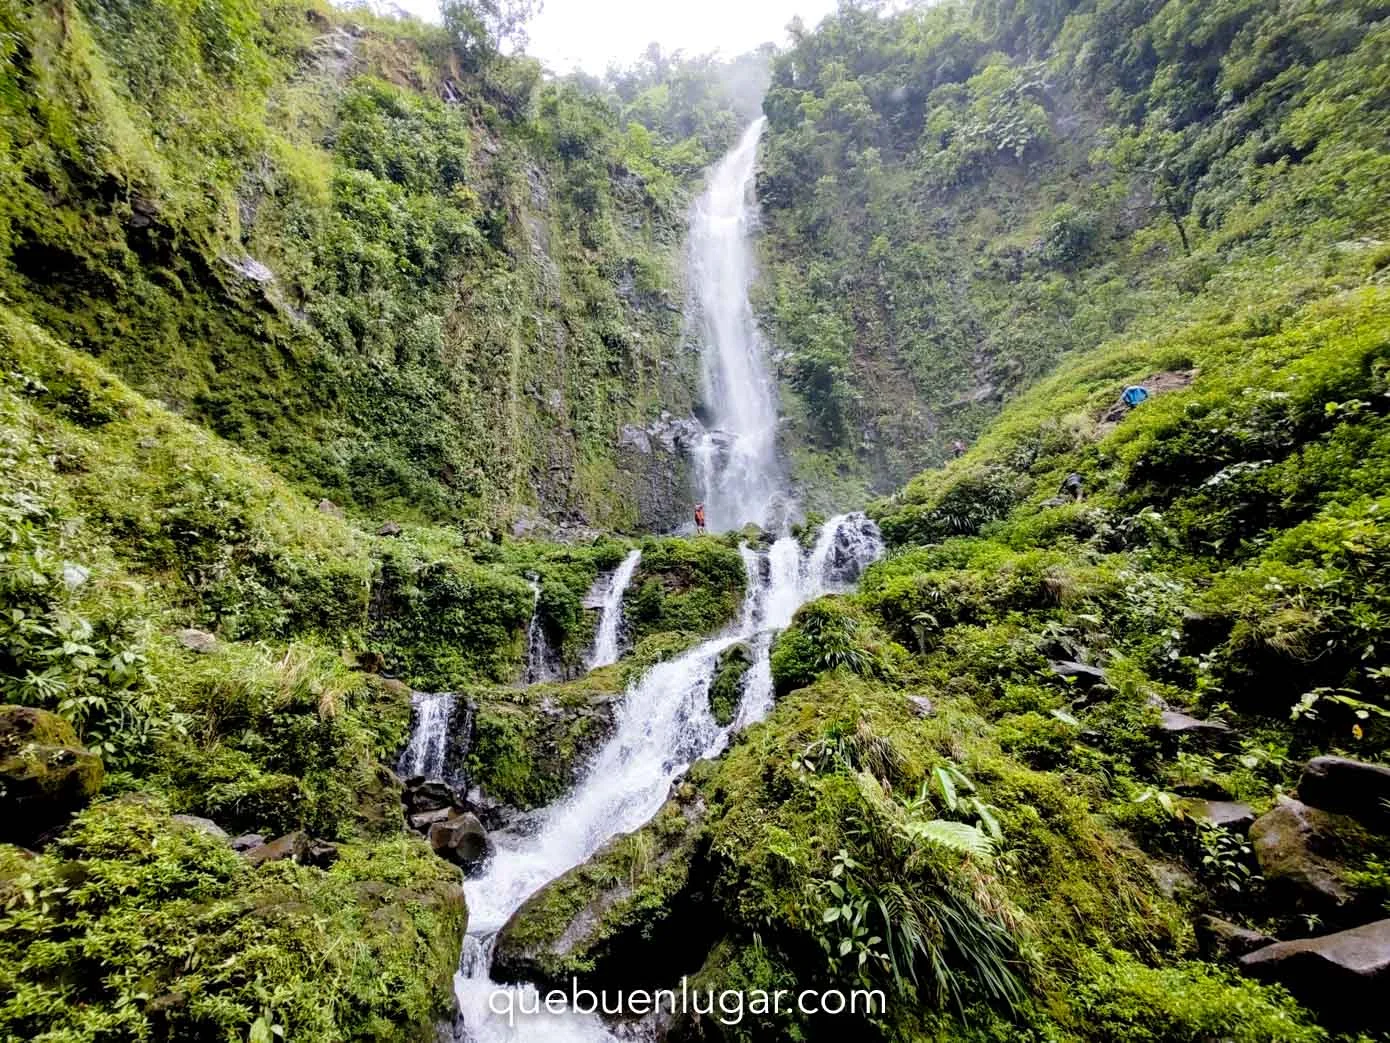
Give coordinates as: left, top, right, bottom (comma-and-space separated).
391, 121, 883, 1043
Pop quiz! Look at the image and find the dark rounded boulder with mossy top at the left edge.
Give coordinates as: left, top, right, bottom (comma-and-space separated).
0, 706, 106, 844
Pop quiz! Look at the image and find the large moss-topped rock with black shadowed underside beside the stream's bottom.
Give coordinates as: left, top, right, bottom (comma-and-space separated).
492, 786, 719, 989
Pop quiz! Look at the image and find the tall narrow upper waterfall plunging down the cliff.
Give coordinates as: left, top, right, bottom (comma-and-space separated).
689, 120, 784, 533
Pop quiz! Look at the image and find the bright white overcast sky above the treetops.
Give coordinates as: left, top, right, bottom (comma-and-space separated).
380, 0, 835, 74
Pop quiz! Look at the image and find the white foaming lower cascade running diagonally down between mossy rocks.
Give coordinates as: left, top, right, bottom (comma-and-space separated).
439, 513, 883, 1043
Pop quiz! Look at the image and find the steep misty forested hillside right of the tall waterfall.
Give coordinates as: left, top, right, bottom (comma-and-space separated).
759, 0, 1390, 511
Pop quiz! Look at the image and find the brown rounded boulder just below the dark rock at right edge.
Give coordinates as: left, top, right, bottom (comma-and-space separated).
1250, 797, 1355, 914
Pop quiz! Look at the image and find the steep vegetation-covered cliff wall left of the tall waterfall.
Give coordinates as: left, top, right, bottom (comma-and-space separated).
0, 0, 692, 528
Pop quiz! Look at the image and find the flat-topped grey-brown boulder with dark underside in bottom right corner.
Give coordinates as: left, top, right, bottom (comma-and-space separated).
1240, 919, 1390, 1029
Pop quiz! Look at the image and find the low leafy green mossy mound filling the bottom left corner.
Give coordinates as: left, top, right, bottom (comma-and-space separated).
0, 798, 466, 1040
